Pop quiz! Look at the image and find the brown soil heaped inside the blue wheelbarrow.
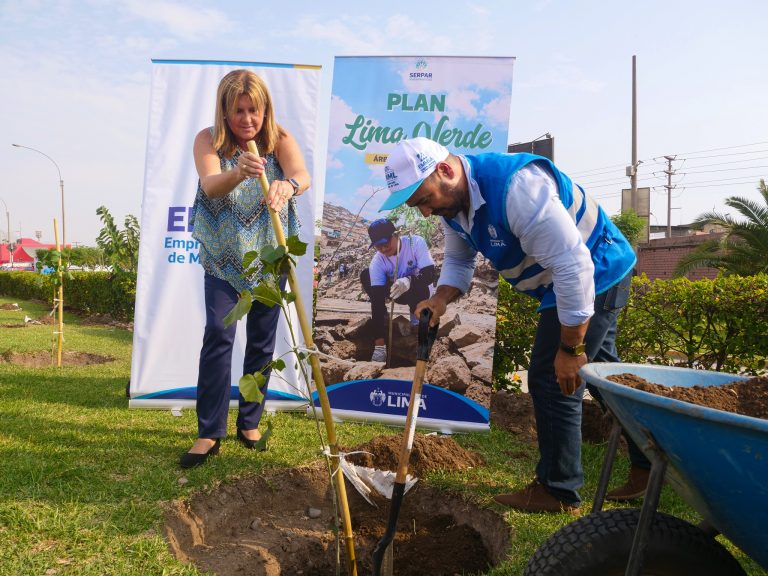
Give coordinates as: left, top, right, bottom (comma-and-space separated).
608, 374, 768, 419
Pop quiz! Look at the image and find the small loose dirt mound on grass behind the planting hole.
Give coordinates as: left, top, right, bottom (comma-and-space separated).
343, 434, 484, 478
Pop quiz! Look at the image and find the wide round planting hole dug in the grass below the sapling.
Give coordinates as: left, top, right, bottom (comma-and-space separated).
165, 437, 509, 576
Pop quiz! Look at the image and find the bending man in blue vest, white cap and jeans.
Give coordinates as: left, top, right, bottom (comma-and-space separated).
381, 138, 650, 512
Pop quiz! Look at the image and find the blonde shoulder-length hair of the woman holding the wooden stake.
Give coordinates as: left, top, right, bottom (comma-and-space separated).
213, 70, 285, 157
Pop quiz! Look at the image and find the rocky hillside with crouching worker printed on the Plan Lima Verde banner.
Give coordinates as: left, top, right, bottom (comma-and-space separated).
314, 198, 498, 408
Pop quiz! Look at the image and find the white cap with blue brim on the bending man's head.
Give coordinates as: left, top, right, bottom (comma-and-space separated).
379, 137, 448, 212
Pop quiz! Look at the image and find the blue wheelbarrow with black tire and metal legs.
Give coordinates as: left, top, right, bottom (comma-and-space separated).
525, 363, 768, 576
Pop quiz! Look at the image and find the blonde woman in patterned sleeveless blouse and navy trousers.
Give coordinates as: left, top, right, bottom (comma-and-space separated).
179, 70, 310, 468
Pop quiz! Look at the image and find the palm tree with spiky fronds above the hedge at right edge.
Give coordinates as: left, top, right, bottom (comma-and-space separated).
674, 179, 768, 276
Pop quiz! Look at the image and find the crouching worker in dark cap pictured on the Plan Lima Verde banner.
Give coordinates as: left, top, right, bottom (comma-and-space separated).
360, 218, 437, 362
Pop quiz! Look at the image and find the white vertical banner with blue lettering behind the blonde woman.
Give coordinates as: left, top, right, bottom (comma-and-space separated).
130, 60, 320, 410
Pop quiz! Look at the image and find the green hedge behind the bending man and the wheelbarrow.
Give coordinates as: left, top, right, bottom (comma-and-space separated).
494, 274, 768, 378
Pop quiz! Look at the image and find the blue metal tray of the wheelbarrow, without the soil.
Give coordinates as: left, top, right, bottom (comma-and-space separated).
581, 362, 768, 568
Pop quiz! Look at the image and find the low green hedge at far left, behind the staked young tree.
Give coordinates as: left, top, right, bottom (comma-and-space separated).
0, 272, 136, 320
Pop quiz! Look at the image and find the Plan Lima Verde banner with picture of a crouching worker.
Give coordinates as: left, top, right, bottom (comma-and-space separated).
315, 56, 514, 432
